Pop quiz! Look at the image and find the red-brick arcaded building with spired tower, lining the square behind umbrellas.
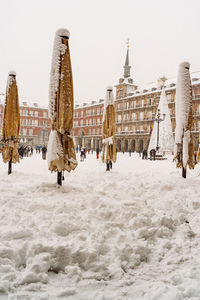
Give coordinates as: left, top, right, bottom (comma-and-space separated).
0, 49, 200, 152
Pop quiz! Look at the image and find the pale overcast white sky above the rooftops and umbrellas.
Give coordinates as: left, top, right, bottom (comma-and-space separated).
0, 0, 200, 106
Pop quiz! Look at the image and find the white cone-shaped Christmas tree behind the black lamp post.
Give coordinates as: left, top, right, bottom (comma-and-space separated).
148, 88, 174, 153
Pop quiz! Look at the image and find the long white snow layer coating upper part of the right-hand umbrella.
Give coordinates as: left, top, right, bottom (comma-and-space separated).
175, 62, 192, 144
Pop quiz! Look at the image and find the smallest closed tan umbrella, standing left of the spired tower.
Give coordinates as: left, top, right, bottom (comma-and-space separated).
102, 86, 117, 171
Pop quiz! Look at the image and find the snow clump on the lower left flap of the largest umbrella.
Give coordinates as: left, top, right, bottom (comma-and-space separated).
47, 130, 63, 168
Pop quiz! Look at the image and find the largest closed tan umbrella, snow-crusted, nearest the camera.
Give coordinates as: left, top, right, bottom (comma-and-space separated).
47, 29, 77, 185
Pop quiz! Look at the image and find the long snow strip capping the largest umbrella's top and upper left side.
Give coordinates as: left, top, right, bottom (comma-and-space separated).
49, 29, 70, 123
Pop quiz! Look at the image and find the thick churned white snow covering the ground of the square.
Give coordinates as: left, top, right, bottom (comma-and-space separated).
0, 153, 200, 300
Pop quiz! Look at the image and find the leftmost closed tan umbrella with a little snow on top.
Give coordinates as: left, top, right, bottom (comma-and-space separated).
2, 71, 20, 174
